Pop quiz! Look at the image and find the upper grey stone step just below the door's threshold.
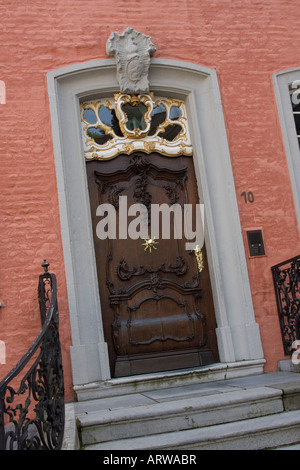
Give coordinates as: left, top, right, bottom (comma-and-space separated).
76, 387, 284, 446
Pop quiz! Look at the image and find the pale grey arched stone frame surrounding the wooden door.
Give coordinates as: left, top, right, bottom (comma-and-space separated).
47, 59, 264, 386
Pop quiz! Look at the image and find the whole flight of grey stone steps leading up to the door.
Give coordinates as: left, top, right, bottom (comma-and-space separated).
74, 372, 300, 450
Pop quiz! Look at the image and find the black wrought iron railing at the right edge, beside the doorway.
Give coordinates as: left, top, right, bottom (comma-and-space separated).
271, 255, 300, 355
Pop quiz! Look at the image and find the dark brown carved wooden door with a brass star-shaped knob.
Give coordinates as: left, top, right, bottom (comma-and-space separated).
87, 153, 218, 377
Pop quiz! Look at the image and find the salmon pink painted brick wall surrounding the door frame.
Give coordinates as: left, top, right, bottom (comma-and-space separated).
0, 0, 300, 400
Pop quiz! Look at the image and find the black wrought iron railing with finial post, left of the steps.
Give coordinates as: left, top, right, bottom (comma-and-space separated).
0, 262, 65, 450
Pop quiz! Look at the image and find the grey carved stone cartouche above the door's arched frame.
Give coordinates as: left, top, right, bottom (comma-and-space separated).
106, 28, 156, 94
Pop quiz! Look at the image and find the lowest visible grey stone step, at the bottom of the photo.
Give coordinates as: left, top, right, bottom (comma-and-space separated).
87, 410, 300, 451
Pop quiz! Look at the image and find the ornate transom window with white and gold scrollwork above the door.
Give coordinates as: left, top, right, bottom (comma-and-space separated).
81, 93, 192, 160
